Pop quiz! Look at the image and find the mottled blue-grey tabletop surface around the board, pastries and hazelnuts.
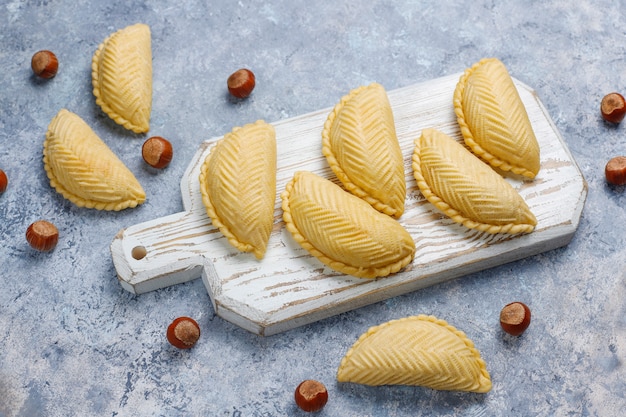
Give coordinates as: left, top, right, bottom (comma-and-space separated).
0, 0, 626, 417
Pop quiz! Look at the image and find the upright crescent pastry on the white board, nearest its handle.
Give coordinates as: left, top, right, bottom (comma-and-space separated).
200, 120, 276, 259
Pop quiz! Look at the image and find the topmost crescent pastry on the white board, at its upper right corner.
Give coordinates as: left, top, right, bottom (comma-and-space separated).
454, 58, 540, 178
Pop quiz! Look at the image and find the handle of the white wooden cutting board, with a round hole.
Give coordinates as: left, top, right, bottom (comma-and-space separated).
111, 212, 224, 294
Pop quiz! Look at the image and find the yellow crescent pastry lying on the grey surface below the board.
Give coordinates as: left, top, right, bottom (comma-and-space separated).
337, 315, 491, 393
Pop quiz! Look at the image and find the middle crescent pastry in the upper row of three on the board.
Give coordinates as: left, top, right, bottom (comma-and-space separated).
322, 83, 406, 218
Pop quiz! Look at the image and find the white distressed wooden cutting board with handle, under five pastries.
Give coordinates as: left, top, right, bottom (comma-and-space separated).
111, 74, 587, 335
